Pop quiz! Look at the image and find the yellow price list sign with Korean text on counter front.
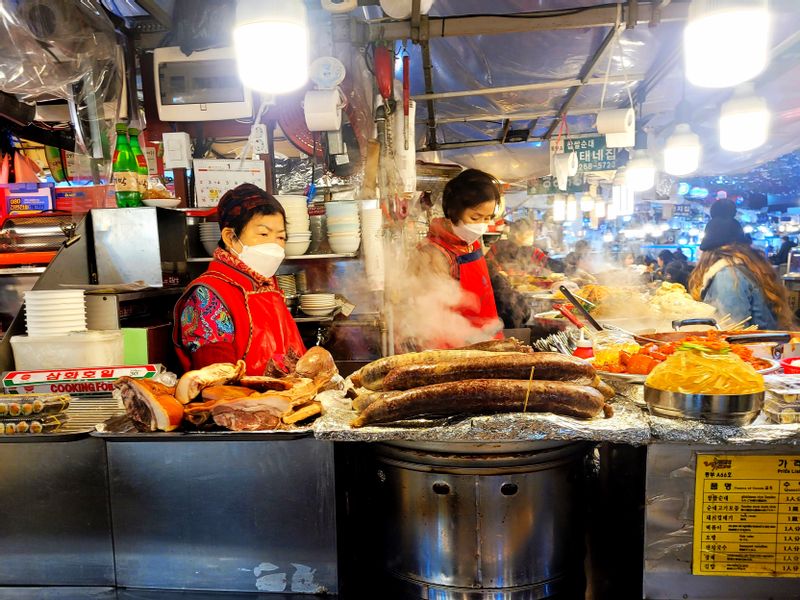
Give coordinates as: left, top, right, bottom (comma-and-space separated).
692, 454, 800, 577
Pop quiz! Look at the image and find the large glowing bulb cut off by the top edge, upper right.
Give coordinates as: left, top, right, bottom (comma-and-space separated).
683, 0, 770, 88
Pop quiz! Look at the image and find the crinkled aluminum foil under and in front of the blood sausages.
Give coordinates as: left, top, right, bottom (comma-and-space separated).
313, 392, 650, 446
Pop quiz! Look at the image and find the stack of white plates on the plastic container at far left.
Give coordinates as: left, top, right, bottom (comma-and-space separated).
25, 290, 86, 336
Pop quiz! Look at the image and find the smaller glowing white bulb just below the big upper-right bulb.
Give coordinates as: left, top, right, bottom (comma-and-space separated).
719, 83, 770, 152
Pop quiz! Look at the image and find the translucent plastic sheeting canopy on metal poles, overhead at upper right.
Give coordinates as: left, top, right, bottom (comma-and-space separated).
359, 0, 800, 181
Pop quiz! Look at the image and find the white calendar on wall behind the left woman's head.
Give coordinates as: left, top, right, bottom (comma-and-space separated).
192, 158, 267, 208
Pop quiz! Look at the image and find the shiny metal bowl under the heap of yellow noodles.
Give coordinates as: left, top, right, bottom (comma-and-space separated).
644, 385, 764, 425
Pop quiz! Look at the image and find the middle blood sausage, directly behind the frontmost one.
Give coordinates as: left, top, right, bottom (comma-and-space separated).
383, 352, 596, 390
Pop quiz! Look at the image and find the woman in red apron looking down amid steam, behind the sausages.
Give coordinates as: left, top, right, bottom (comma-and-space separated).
422, 169, 502, 341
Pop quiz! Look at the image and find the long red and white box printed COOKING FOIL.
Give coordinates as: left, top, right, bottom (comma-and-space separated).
2, 364, 163, 396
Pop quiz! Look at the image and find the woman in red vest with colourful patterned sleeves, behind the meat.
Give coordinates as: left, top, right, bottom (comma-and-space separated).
173, 184, 305, 375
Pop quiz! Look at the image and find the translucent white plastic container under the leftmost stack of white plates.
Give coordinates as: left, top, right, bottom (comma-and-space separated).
11, 330, 124, 371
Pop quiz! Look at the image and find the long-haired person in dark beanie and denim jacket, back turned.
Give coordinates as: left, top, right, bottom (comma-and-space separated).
689, 199, 794, 329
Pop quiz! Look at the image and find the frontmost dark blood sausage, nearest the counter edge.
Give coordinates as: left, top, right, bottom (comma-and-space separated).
352, 379, 605, 427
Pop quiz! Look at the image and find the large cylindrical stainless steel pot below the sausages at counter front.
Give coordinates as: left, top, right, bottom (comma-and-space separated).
378, 442, 587, 600
